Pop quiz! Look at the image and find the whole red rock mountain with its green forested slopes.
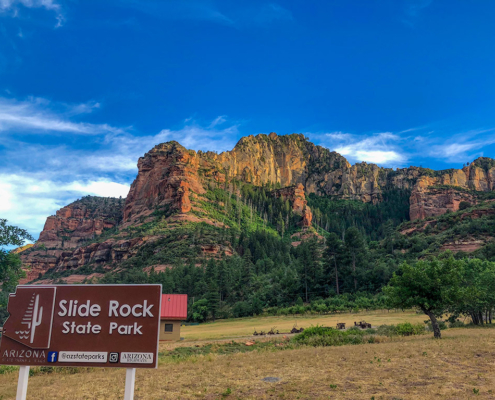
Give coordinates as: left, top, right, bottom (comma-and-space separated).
13, 133, 495, 322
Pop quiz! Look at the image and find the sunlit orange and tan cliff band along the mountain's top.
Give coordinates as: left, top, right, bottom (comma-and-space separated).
124, 132, 495, 224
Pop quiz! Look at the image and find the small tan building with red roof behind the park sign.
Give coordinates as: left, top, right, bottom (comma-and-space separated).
160, 294, 187, 340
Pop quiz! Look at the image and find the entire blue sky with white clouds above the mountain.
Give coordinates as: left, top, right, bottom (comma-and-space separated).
0, 0, 495, 236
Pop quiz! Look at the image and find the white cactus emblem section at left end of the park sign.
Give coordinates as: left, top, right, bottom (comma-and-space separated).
3, 286, 57, 349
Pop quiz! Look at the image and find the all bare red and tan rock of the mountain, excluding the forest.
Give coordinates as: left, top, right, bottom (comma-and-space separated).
17, 132, 495, 280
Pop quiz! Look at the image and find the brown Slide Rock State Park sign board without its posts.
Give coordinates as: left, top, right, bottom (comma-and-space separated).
0, 285, 162, 368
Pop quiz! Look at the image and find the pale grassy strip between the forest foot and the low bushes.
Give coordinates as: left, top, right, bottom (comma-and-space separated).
181, 310, 428, 342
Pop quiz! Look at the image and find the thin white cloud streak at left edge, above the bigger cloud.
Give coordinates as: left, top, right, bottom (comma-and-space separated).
0, 97, 122, 135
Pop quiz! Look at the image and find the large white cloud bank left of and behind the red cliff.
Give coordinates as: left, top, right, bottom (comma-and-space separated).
0, 98, 239, 237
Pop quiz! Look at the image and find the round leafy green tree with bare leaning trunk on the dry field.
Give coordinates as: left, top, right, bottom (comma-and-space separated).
383, 257, 461, 339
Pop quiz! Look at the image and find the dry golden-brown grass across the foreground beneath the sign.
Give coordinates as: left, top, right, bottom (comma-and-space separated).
0, 329, 495, 400
